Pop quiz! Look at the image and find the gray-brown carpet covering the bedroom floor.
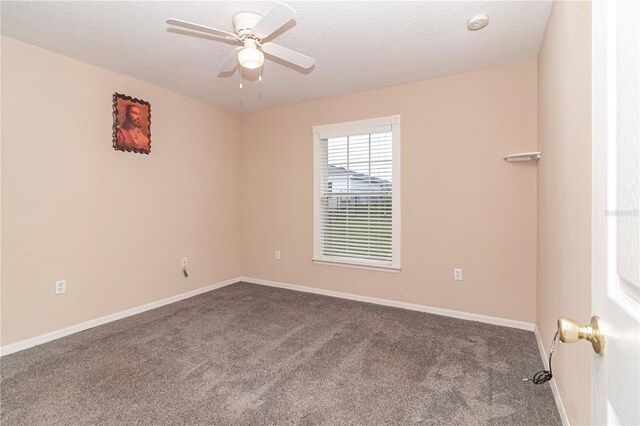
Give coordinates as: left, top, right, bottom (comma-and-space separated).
0, 283, 561, 426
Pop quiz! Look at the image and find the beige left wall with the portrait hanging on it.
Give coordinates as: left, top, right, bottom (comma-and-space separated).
1, 37, 242, 345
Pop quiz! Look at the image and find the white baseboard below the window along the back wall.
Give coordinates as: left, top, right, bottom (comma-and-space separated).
241, 277, 535, 331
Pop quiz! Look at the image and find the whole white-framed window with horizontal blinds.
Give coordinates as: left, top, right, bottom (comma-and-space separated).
313, 115, 400, 270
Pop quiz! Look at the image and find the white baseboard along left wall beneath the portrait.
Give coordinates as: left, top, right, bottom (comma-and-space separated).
0, 278, 240, 356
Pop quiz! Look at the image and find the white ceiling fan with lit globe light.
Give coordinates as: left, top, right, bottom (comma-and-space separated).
167, 3, 315, 73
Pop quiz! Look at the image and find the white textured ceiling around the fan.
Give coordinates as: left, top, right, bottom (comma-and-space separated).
0, 1, 551, 112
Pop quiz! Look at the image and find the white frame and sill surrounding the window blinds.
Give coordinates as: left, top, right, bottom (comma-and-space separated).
313, 115, 401, 272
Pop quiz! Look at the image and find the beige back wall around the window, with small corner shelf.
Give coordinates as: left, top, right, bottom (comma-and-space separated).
242, 61, 537, 322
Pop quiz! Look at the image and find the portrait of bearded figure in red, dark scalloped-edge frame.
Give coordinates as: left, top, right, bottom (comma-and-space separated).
113, 93, 151, 154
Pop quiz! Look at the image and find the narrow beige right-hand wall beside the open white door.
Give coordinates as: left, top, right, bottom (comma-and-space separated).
537, 2, 591, 424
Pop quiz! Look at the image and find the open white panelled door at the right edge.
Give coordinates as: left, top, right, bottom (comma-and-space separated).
591, 0, 640, 425
